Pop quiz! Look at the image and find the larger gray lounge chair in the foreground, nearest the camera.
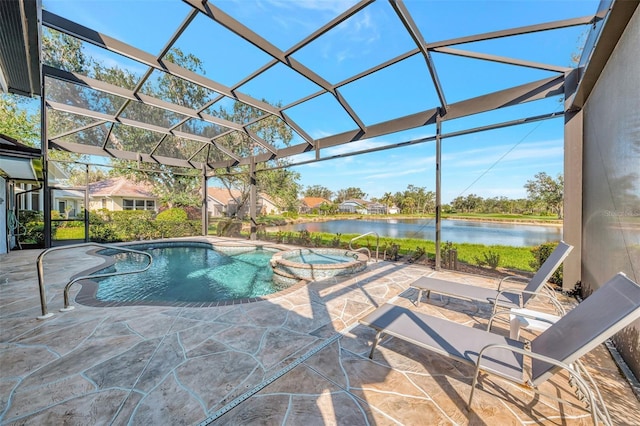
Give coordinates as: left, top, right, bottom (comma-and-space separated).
360, 273, 640, 424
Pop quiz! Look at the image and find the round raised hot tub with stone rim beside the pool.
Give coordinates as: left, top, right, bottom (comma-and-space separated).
271, 248, 369, 284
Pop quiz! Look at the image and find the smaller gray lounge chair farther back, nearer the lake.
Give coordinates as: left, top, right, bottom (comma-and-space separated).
410, 241, 573, 312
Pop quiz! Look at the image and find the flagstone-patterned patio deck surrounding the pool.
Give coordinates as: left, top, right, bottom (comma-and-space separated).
0, 237, 640, 425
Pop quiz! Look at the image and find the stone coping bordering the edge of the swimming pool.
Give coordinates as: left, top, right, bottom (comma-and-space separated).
71, 238, 309, 308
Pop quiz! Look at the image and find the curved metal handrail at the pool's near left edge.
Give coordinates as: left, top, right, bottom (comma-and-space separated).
36, 243, 153, 319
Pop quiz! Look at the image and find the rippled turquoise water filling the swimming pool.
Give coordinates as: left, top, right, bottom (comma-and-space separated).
96, 246, 281, 302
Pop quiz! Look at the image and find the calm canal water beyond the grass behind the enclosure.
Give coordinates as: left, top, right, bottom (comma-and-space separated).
277, 219, 562, 247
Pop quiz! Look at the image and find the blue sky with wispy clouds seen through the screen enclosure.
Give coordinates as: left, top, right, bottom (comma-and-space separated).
43, 0, 599, 203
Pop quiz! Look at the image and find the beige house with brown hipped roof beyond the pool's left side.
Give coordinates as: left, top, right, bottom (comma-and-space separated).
89, 177, 158, 211
